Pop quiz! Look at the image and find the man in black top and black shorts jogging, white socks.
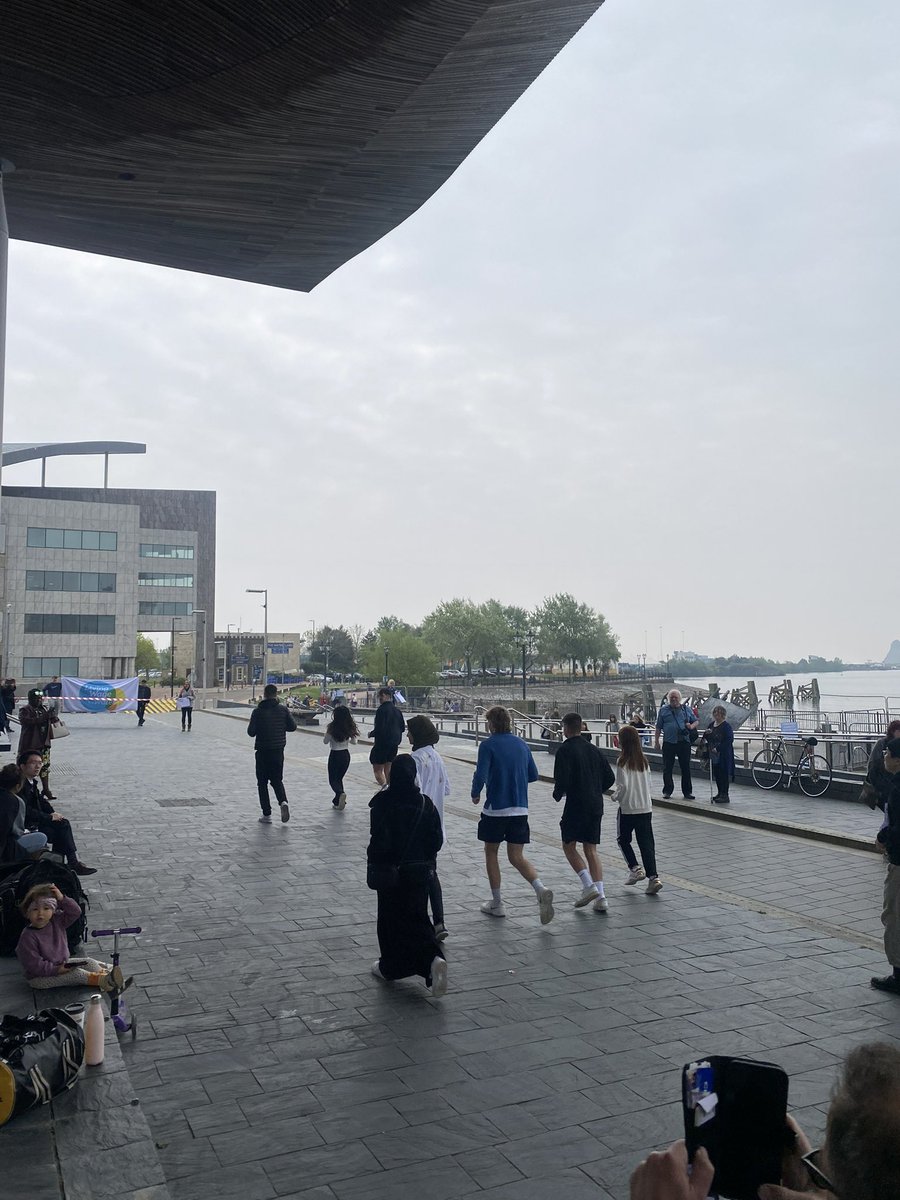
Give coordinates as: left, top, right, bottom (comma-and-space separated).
553, 713, 616, 912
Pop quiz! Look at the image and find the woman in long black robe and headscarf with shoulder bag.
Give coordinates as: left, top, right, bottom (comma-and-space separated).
366, 754, 446, 996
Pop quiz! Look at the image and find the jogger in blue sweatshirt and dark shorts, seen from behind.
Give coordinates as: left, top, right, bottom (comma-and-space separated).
472, 704, 553, 925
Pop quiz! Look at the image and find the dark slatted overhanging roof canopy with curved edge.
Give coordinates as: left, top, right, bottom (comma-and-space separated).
0, 0, 602, 290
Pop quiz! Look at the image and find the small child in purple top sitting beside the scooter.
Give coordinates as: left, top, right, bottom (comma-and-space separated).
16, 883, 125, 991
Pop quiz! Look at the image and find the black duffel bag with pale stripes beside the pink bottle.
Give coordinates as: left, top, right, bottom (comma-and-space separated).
0, 1008, 84, 1126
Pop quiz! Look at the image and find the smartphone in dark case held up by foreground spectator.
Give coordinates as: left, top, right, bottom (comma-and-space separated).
682, 1055, 793, 1200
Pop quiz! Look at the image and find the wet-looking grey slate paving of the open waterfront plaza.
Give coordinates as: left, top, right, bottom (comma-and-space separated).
0, 713, 900, 1200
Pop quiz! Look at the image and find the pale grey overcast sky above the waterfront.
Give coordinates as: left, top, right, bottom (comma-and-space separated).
4, 0, 900, 661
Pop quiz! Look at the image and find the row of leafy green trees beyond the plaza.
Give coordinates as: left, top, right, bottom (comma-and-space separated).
303, 593, 620, 686
